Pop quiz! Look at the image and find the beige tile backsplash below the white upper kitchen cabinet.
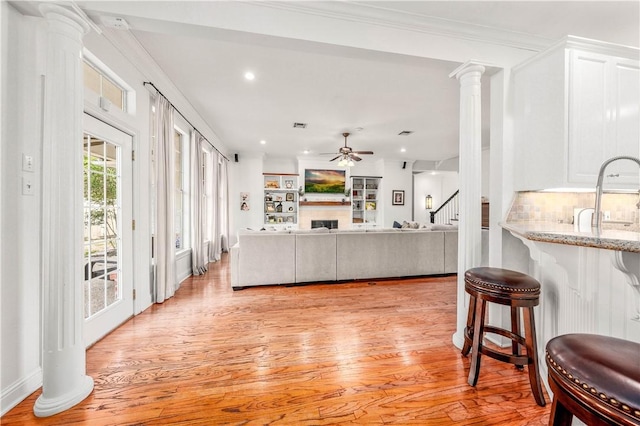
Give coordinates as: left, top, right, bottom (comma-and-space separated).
507, 191, 640, 231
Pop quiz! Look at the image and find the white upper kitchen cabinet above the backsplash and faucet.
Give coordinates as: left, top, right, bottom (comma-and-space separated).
513, 37, 640, 191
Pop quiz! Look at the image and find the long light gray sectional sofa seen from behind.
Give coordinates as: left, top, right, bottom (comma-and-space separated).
231, 228, 458, 290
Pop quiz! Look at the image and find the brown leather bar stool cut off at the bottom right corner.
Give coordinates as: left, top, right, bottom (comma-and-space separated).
546, 334, 640, 426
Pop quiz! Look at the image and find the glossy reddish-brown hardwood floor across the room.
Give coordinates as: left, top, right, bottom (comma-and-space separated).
0, 258, 551, 425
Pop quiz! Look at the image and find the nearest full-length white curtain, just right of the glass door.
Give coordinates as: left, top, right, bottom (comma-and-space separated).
154, 95, 177, 303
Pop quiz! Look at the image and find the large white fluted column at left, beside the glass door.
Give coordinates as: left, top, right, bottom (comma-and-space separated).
33, 3, 93, 417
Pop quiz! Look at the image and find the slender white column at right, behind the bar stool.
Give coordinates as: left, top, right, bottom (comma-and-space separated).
449, 62, 485, 348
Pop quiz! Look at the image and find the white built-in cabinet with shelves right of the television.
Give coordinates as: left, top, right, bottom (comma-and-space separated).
351, 176, 381, 228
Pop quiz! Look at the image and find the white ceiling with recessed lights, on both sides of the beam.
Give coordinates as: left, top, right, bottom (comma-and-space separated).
45, 1, 640, 165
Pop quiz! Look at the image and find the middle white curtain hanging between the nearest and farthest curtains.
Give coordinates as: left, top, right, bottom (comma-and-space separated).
189, 130, 209, 275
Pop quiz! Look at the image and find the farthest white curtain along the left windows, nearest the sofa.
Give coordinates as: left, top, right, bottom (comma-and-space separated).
209, 152, 229, 261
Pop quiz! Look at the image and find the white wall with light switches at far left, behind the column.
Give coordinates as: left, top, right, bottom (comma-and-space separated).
0, 2, 44, 414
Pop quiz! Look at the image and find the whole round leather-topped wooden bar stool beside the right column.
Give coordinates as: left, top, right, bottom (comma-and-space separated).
462, 268, 545, 406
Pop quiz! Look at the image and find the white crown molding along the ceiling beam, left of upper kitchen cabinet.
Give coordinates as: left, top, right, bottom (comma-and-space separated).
250, 1, 556, 52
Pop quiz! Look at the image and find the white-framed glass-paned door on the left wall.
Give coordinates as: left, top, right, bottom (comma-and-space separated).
82, 114, 133, 347
